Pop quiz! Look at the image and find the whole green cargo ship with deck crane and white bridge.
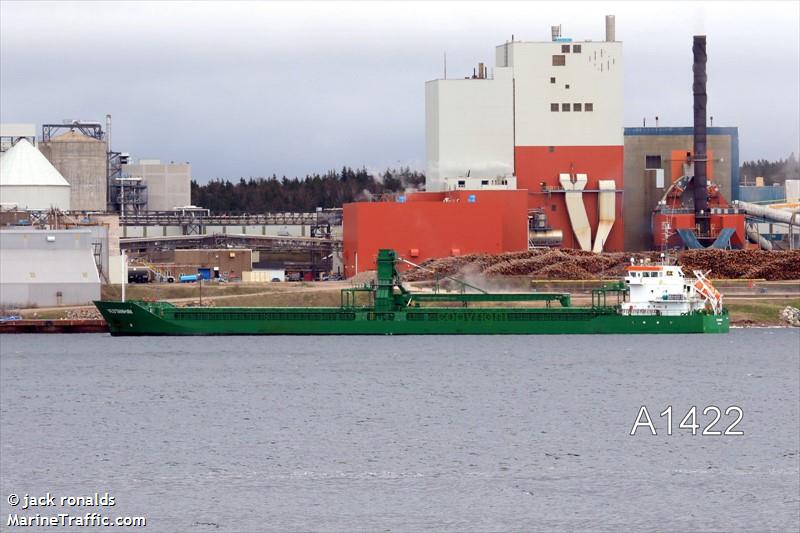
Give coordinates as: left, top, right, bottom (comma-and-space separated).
95, 250, 729, 336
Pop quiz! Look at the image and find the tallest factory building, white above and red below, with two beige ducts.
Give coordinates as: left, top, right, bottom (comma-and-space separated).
425, 16, 624, 250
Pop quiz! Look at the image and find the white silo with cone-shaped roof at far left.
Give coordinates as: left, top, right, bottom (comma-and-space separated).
0, 139, 70, 211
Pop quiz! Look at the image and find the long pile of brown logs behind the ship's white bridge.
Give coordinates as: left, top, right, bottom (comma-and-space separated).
403, 249, 800, 281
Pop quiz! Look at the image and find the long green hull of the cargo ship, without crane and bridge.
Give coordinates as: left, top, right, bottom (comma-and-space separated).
95, 301, 729, 335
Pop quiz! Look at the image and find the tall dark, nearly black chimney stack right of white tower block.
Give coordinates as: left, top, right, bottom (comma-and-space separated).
692, 35, 708, 229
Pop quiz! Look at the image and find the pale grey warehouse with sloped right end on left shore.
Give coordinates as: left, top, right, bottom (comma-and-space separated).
0, 229, 100, 308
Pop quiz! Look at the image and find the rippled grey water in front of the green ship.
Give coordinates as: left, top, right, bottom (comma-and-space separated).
0, 329, 800, 532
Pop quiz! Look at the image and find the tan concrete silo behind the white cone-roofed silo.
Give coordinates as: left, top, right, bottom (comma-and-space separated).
39, 130, 108, 211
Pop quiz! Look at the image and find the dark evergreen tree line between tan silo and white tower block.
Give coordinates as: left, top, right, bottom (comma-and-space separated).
191, 166, 425, 215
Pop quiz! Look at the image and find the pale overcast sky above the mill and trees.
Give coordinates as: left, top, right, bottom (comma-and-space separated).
0, 0, 800, 182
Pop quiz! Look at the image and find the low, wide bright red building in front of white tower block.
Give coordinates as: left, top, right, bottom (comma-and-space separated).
343, 190, 528, 278
